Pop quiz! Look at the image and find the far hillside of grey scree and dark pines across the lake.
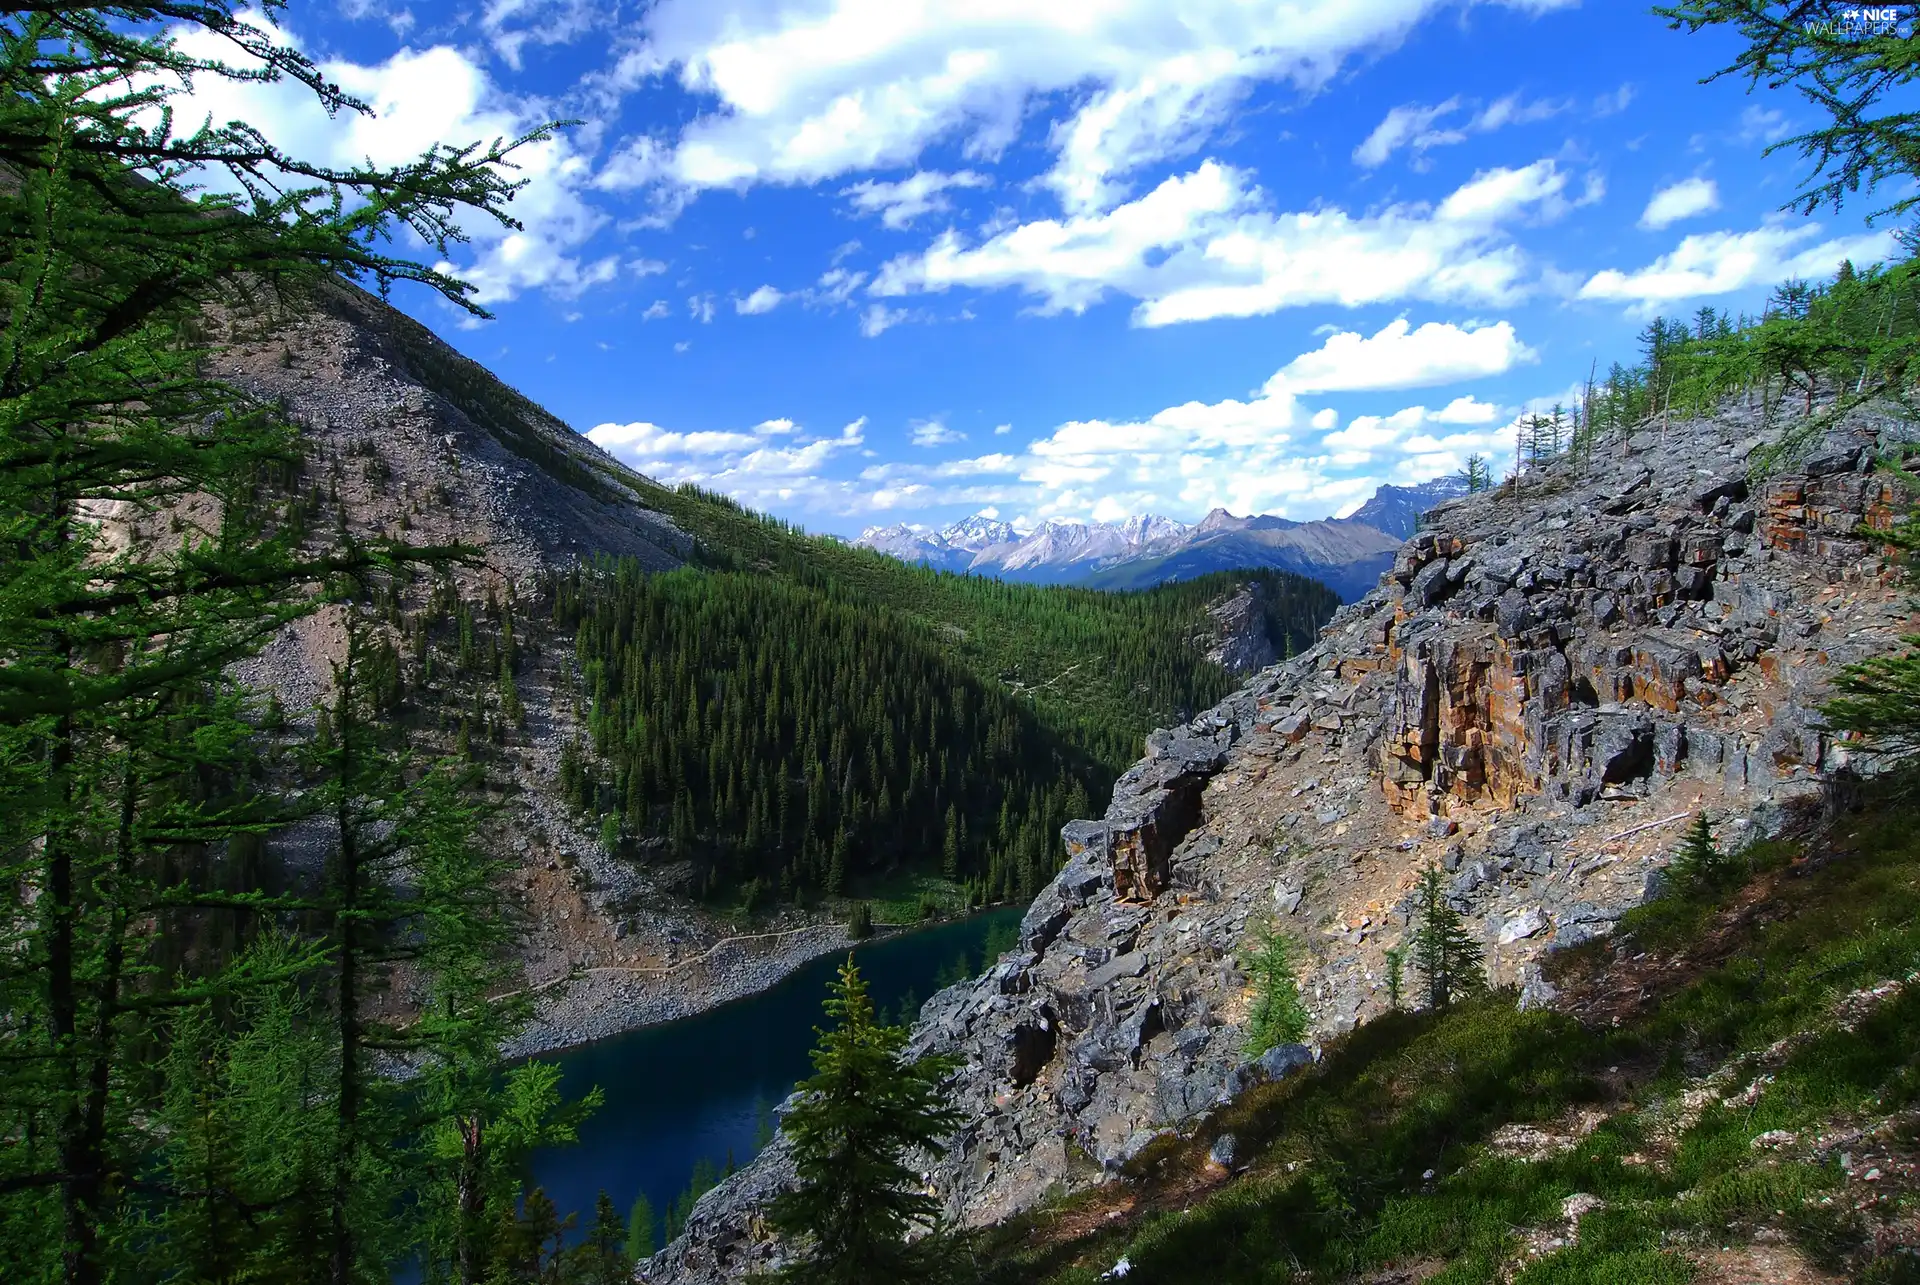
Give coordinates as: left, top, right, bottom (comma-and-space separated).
198, 286, 1334, 1021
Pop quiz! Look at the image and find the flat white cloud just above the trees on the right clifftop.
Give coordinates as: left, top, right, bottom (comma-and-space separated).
1580, 223, 1895, 311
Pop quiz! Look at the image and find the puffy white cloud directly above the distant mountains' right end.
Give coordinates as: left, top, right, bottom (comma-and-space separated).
1267, 317, 1538, 392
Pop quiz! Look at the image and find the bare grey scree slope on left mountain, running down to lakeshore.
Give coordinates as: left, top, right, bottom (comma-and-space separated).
194, 286, 883, 1051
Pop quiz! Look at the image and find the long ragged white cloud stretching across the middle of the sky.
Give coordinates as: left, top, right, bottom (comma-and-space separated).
870, 159, 1569, 327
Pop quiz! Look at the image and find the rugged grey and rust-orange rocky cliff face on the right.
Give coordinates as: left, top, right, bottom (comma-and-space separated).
645, 403, 1910, 1281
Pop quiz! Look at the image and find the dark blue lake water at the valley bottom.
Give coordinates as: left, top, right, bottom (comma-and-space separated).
532, 909, 1020, 1237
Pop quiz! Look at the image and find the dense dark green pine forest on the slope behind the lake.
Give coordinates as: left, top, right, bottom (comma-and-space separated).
551, 560, 1332, 905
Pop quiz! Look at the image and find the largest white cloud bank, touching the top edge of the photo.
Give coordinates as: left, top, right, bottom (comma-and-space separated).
614, 0, 1571, 213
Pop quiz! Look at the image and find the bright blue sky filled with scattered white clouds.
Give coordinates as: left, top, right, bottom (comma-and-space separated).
198, 0, 1891, 534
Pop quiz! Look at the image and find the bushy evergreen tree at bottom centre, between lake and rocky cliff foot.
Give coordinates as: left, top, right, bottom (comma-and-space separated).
768, 957, 960, 1285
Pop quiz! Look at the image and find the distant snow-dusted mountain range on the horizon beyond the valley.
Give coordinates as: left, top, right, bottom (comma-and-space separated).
854, 476, 1467, 601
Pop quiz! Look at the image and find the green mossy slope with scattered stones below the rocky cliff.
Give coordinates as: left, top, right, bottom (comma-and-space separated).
964, 799, 1920, 1285
